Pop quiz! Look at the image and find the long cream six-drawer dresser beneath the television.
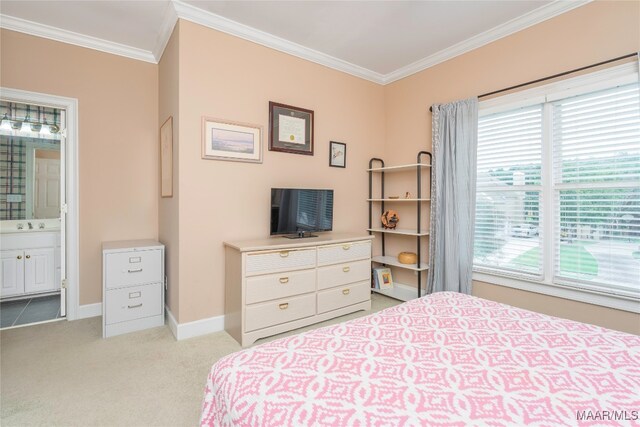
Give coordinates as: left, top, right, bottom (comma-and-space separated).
224, 233, 373, 347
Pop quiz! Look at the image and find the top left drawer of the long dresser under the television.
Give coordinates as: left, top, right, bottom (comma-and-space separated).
245, 248, 316, 276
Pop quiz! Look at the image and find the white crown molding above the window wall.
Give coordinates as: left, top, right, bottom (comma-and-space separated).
382, 0, 592, 85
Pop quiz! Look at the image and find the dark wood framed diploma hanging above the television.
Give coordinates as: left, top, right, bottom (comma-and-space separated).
269, 102, 313, 156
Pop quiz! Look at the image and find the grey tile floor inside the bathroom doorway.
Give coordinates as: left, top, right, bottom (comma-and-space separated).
0, 295, 61, 328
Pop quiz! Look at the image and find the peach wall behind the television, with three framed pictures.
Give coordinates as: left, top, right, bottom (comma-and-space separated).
179, 21, 385, 323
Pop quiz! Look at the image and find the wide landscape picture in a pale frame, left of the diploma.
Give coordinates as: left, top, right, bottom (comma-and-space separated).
202, 117, 262, 163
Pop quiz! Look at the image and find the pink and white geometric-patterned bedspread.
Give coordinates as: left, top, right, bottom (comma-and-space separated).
201, 292, 640, 426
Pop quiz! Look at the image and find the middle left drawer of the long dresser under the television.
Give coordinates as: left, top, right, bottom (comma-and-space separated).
245, 270, 316, 304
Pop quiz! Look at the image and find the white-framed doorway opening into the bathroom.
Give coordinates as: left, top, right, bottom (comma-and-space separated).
0, 88, 78, 328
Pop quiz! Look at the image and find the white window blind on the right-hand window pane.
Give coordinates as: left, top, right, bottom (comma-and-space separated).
552, 84, 640, 294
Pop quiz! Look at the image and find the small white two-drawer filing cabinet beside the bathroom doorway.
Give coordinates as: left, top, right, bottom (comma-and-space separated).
102, 240, 164, 338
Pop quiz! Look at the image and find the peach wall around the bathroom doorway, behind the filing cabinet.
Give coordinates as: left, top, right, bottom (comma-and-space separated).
0, 30, 158, 304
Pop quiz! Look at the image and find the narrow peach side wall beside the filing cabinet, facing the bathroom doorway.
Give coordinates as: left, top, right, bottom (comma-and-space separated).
158, 23, 180, 316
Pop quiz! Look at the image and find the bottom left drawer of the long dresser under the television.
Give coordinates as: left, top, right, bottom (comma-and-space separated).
245, 294, 316, 332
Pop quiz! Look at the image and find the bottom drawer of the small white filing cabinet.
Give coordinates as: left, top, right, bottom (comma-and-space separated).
105, 283, 162, 325
